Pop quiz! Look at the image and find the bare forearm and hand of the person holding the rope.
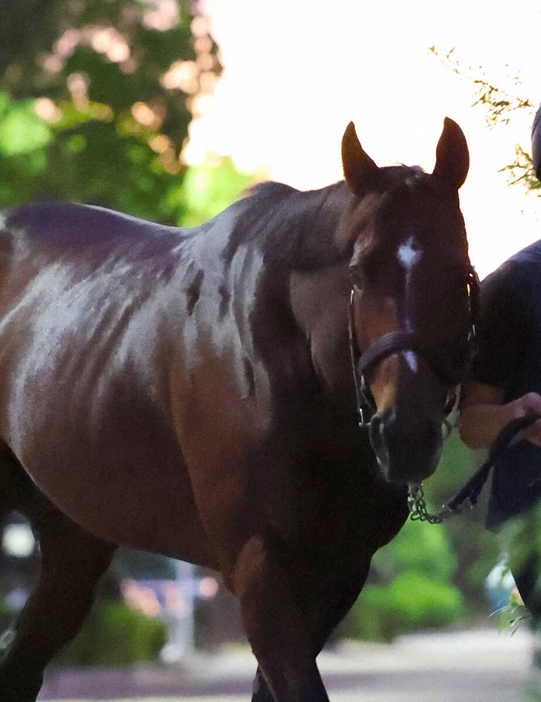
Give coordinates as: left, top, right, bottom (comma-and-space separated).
459, 382, 541, 449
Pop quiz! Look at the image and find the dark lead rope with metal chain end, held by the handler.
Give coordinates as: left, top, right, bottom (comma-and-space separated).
408, 414, 541, 524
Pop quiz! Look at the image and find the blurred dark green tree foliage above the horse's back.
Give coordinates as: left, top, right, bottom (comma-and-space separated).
0, 0, 220, 223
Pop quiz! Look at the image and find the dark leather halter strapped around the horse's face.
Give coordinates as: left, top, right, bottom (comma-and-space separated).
348, 267, 479, 429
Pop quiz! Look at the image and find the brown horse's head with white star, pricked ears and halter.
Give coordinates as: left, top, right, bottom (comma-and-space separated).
342, 119, 476, 485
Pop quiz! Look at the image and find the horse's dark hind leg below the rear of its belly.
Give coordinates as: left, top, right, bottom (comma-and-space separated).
0, 506, 115, 702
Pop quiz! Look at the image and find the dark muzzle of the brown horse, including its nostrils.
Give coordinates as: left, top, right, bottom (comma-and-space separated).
370, 410, 443, 484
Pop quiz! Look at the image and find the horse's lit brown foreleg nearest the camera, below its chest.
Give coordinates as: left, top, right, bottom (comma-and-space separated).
233, 537, 328, 702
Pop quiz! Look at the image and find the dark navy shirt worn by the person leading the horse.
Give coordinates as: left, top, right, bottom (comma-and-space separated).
472, 241, 541, 528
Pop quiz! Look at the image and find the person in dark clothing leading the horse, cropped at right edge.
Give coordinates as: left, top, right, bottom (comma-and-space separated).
459, 102, 541, 625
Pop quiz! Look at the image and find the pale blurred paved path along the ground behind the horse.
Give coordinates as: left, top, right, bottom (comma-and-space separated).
39, 631, 531, 702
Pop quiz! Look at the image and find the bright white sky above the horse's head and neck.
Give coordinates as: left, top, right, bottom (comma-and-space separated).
187, 0, 541, 276
